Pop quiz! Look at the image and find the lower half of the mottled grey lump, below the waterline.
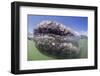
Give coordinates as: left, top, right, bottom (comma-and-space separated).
33, 22, 80, 58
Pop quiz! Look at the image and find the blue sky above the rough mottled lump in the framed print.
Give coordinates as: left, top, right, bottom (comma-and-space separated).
28, 15, 88, 35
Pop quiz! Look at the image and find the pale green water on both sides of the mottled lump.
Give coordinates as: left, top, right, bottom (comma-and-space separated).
27, 38, 88, 61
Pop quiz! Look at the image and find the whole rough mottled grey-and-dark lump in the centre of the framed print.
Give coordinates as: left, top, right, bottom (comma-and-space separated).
33, 20, 80, 58
